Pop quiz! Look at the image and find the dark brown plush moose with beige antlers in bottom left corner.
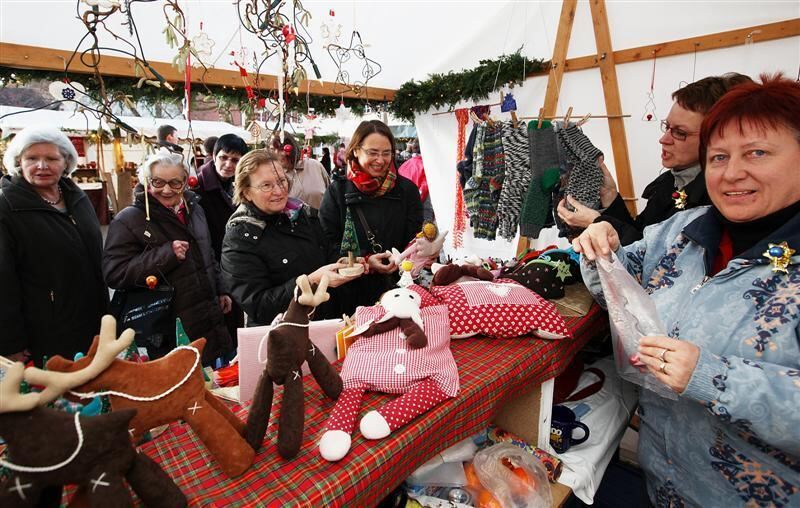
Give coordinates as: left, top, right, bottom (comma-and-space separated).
0, 316, 186, 508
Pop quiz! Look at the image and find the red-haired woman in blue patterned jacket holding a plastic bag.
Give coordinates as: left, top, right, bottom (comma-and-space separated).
574, 76, 800, 506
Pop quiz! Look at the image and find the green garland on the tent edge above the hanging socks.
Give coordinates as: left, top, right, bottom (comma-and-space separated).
389, 51, 548, 122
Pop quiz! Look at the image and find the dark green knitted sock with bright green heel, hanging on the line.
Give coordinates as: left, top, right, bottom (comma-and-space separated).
520, 122, 559, 238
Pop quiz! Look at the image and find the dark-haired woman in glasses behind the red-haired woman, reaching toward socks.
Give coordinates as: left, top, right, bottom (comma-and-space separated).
557, 72, 751, 245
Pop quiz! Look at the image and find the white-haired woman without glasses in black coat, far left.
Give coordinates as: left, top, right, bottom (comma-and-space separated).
0, 127, 108, 366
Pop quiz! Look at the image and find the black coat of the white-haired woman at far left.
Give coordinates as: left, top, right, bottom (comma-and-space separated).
0, 176, 108, 366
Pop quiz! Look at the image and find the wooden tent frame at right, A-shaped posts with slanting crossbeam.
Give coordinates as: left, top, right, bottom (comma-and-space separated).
517, 0, 800, 253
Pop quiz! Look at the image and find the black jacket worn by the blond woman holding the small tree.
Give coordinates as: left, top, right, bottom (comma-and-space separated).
221, 203, 340, 326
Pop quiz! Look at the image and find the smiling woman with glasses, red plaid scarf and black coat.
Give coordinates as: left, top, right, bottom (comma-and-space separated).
319, 120, 422, 313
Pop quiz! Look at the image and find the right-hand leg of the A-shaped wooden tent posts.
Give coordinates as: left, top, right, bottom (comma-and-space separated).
589, 0, 636, 217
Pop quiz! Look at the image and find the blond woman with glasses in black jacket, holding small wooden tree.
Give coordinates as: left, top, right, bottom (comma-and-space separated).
221, 150, 358, 326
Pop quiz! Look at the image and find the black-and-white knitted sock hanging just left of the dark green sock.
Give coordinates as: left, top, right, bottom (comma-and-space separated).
497, 123, 531, 240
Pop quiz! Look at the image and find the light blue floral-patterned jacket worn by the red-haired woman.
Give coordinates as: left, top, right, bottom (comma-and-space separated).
581, 207, 800, 507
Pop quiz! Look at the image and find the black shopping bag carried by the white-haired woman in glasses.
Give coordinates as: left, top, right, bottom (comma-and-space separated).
111, 285, 175, 360
